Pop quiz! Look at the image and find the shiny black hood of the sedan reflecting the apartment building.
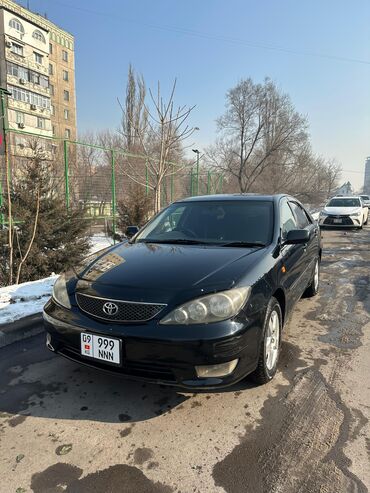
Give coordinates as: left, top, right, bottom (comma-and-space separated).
76, 242, 264, 302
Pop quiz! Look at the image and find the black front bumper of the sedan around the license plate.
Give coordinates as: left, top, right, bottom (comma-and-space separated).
44, 300, 264, 389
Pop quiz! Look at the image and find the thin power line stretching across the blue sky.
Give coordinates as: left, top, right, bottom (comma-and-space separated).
42, 0, 370, 65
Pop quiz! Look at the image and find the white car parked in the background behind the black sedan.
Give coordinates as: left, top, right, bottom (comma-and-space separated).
319, 197, 369, 229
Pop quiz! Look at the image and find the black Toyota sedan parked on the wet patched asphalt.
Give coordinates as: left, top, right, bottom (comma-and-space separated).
44, 195, 321, 389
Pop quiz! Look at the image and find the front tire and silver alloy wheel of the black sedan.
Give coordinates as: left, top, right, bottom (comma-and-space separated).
251, 297, 283, 385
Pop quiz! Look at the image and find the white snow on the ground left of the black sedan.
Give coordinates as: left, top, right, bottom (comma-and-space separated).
0, 235, 113, 325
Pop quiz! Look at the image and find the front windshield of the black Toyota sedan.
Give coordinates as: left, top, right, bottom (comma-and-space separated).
135, 200, 273, 246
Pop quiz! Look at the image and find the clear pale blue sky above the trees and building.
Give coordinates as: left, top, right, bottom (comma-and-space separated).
18, 0, 370, 190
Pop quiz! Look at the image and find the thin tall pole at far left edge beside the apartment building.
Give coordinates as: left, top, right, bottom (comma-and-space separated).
0, 87, 13, 284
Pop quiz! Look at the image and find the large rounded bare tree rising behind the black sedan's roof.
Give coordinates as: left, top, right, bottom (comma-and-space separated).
208, 79, 307, 193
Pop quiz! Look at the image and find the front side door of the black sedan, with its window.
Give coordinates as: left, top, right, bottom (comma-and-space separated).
280, 198, 307, 309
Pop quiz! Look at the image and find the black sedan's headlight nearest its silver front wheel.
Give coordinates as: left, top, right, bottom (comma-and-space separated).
160, 287, 251, 325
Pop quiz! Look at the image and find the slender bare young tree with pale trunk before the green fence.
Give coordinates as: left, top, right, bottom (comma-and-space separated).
121, 80, 195, 213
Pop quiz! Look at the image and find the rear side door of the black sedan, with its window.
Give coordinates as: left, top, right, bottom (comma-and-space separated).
289, 200, 319, 293
